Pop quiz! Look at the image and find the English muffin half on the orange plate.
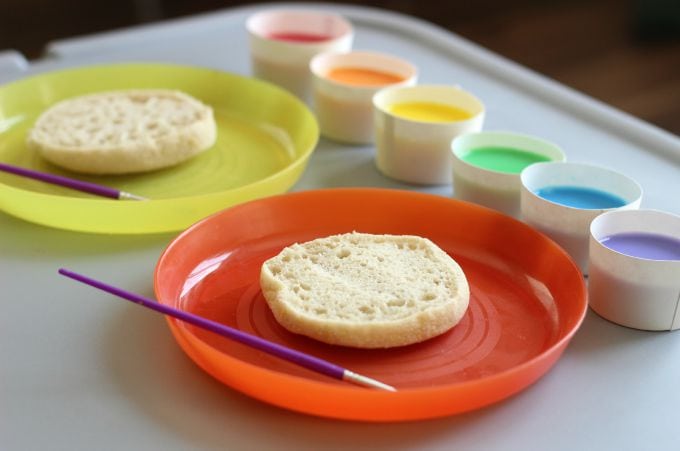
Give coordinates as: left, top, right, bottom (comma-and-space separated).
260, 232, 470, 348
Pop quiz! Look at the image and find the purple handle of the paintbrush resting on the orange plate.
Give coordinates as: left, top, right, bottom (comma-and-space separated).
59, 268, 345, 380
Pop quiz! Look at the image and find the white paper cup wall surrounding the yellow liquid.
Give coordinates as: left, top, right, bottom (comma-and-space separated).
373, 85, 485, 185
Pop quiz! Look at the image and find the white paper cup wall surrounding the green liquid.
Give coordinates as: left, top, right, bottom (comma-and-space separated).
451, 131, 565, 218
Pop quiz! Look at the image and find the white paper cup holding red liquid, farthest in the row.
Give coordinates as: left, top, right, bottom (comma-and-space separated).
246, 9, 354, 102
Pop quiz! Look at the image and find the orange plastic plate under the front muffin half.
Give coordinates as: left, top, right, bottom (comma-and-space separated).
155, 189, 586, 421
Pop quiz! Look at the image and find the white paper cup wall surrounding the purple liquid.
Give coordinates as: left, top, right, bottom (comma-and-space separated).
588, 210, 680, 331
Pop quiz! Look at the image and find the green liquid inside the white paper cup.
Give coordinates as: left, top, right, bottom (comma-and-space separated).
460, 146, 552, 174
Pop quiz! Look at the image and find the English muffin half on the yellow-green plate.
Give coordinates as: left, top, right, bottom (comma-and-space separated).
27, 89, 217, 174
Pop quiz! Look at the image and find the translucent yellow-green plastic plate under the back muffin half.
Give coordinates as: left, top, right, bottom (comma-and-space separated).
0, 64, 319, 234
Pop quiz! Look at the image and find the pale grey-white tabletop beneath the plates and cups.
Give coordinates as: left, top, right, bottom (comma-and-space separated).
0, 4, 680, 450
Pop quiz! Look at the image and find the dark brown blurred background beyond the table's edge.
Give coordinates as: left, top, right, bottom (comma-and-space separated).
0, 0, 680, 134
